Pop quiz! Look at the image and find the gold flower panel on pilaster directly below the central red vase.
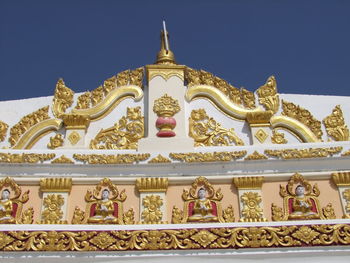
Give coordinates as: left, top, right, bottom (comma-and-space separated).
141, 195, 163, 224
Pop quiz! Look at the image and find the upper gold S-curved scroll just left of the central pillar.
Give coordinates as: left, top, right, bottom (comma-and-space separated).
72, 85, 143, 121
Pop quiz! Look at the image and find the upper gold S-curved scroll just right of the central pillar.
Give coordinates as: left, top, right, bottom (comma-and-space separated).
185, 85, 262, 120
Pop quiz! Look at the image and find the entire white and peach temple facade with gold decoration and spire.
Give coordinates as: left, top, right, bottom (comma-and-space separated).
0, 27, 350, 263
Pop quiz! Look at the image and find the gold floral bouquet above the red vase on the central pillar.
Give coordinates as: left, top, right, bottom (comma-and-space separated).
153, 94, 180, 117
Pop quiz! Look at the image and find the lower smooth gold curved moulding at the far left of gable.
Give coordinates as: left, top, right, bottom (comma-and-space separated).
12, 119, 62, 149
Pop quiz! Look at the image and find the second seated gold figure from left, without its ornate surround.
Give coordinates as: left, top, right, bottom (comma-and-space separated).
88, 189, 118, 224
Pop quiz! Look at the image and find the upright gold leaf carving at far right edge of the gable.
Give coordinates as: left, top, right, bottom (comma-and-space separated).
323, 105, 350, 141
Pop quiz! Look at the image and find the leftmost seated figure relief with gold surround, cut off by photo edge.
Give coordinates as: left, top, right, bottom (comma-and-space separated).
0, 177, 32, 225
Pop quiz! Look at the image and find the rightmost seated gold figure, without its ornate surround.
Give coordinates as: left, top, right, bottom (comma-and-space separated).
288, 185, 320, 219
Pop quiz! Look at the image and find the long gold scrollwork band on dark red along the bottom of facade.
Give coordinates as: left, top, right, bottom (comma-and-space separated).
0, 224, 350, 251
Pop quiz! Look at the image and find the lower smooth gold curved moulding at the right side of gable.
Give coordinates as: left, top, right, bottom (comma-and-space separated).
270, 116, 321, 142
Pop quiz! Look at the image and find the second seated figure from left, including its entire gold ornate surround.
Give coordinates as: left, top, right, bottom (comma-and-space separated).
72, 178, 134, 224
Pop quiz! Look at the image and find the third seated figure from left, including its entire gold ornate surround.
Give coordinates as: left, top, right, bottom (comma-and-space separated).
172, 177, 234, 224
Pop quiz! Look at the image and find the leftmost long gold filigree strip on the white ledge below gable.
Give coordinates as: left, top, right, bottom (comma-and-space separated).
0, 153, 56, 163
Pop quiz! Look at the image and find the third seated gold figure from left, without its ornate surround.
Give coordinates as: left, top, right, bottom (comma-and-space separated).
187, 188, 219, 222
